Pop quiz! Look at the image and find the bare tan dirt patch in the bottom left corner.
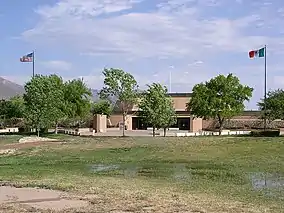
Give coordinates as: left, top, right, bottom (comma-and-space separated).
0, 186, 89, 211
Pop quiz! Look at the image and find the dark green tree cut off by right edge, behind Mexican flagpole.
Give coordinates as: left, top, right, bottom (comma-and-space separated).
258, 89, 284, 121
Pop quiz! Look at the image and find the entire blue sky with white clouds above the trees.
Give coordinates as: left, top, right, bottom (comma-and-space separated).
0, 0, 284, 109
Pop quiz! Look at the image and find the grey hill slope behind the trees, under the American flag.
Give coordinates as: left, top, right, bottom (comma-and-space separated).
0, 77, 25, 99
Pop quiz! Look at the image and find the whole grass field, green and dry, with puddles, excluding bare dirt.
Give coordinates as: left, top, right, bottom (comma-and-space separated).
0, 136, 284, 213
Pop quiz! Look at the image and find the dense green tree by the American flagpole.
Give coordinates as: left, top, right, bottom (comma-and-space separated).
24, 75, 65, 136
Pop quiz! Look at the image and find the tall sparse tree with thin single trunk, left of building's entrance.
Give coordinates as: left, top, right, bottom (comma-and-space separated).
100, 68, 138, 136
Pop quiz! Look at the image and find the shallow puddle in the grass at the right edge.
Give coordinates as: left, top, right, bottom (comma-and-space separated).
250, 172, 284, 192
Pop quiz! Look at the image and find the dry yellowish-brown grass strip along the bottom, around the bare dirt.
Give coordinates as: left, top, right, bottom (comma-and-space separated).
0, 176, 273, 213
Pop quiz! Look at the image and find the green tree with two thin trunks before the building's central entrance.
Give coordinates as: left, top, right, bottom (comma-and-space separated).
138, 83, 176, 137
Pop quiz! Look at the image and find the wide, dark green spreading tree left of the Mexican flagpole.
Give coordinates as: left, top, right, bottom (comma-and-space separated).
187, 74, 253, 135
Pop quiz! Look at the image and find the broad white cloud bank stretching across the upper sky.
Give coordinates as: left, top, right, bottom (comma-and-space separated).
22, 0, 278, 57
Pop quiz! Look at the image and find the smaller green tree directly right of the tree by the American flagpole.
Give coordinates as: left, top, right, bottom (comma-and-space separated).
64, 79, 92, 127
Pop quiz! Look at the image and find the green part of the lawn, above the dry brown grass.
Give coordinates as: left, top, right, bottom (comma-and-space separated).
0, 136, 284, 212
